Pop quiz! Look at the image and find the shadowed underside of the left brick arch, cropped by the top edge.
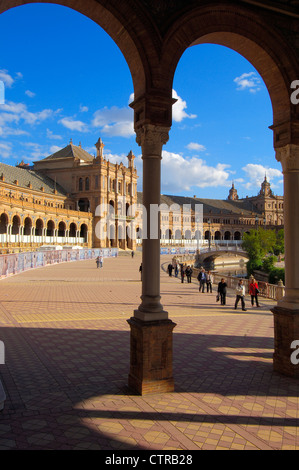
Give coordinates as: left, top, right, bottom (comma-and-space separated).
0, 0, 151, 96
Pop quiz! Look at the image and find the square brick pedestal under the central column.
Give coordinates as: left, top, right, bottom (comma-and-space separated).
128, 317, 176, 395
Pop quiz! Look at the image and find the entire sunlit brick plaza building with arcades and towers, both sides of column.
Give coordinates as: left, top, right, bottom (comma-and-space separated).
0, 139, 283, 258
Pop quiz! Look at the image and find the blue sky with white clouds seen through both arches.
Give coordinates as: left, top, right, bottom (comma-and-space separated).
0, 4, 283, 199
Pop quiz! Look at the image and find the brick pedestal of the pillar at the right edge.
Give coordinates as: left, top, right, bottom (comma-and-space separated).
271, 306, 299, 378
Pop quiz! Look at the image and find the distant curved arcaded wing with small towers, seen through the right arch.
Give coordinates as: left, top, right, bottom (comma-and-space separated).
135, 176, 284, 248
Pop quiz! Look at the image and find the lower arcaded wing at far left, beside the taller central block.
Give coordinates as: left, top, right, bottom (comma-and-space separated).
0, 159, 92, 253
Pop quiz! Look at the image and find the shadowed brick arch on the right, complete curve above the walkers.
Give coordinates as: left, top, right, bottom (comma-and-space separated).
162, 5, 299, 129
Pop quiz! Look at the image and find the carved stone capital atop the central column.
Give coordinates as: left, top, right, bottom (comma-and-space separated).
136, 124, 170, 159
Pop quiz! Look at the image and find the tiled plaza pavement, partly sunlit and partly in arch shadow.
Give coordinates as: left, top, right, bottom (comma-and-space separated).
0, 254, 299, 451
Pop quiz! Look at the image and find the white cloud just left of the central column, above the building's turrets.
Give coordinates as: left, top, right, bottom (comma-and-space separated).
92, 106, 134, 137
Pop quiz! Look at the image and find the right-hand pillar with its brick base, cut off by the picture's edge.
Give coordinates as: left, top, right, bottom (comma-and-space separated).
272, 144, 299, 377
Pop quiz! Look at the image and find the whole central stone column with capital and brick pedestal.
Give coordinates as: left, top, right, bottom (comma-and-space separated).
128, 124, 175, 395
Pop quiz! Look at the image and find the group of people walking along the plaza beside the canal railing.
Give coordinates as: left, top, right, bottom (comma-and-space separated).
167, 263, 259, 312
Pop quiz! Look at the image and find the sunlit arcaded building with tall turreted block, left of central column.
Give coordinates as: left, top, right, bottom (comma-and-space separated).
0, 139, 137, 253
